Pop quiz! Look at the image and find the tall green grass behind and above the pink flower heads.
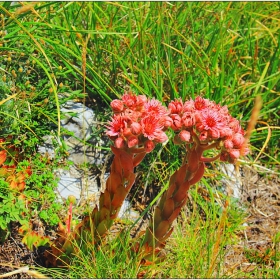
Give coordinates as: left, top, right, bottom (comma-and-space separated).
0, 2, 280, 165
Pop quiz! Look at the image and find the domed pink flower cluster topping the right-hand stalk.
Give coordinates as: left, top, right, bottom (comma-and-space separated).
168, 97, 249, 162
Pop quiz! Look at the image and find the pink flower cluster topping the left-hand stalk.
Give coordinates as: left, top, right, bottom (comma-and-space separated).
106, 92, 168, 153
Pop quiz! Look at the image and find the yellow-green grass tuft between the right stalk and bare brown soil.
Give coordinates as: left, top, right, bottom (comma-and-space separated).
160, 186, 246, 278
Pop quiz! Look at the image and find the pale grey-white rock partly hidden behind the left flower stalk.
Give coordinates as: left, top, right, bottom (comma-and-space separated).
39, 101, 139, 220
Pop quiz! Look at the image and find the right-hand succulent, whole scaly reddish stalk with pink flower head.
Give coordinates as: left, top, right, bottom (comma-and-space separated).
132, 97, 248, 262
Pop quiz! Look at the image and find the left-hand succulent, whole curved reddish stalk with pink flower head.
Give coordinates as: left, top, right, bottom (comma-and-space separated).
46, 93, 171, 266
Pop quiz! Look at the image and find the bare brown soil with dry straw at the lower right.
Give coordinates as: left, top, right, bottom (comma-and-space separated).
223, 167, 280, 278
